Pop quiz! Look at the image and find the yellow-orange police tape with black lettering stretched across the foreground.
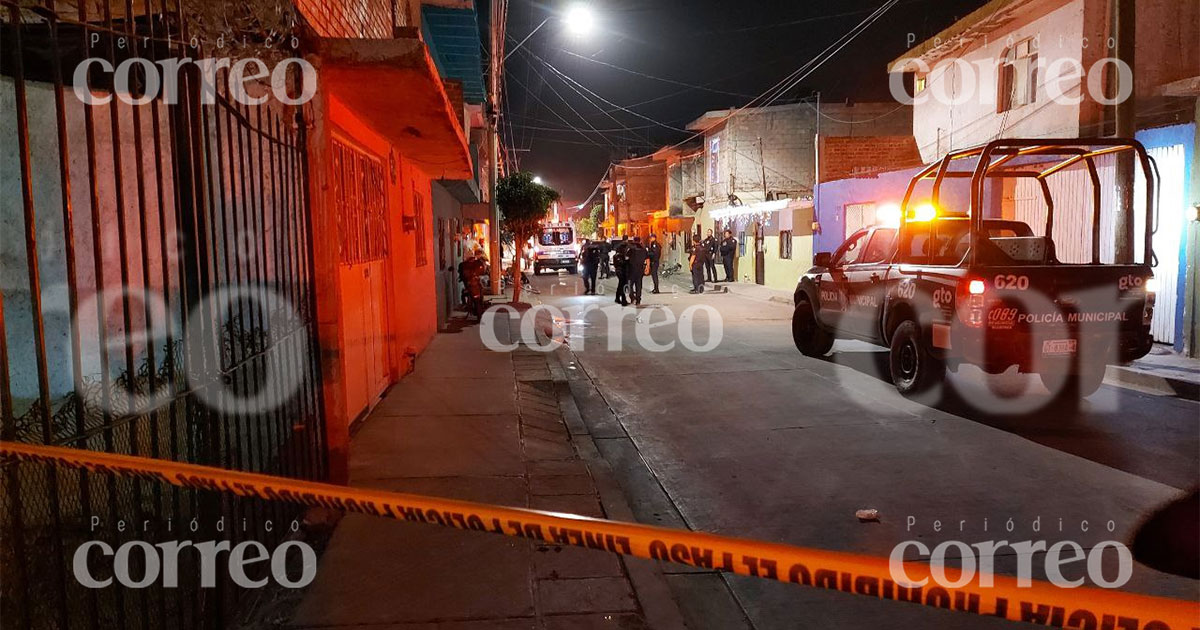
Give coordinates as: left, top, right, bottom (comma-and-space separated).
0, 442, 1200, 630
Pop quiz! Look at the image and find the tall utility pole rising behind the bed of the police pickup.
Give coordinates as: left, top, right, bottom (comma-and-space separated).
1111, 0, 1137, 263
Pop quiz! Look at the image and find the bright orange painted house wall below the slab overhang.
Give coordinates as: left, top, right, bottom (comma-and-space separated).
310, 87, 437, 481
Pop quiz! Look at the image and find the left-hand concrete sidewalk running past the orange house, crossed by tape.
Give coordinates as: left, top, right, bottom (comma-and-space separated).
290, 312, 678, 630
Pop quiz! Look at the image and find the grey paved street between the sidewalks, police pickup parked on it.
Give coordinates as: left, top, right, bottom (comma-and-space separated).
528, 275, 1200, 629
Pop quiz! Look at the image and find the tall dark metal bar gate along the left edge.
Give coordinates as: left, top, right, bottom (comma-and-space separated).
0, 0, 326, 629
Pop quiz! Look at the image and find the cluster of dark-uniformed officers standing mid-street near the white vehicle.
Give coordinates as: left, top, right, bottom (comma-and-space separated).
580, 234, 662, 306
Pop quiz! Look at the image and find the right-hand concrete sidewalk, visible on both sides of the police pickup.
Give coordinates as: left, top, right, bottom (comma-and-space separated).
704, 282, 1200, 401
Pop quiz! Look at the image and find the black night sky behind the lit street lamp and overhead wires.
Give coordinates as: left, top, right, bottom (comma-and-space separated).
496, 0, 985, 203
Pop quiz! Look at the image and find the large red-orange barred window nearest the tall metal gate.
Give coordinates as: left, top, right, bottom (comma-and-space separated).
332, 139, 388, 265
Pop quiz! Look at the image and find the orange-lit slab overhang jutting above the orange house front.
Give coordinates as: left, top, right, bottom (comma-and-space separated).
318, 34, 473, 179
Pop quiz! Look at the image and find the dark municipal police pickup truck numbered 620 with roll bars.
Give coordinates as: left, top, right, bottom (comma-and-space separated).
792, 139, 1156, 398
